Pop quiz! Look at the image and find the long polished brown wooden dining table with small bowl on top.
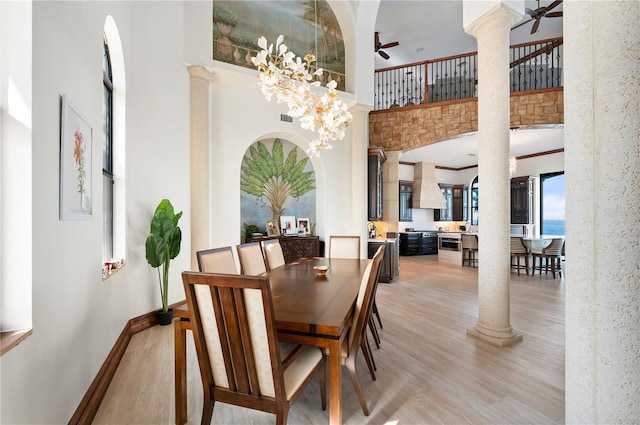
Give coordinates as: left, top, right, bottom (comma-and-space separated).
174, 258, 370, 425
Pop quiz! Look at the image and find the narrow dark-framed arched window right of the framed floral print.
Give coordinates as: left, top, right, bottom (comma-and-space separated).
102, 36, 113, 260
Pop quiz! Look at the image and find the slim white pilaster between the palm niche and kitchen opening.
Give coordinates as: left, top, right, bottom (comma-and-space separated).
348, 103, 372, 258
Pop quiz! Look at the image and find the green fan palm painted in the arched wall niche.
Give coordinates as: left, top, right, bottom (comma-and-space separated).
240, 139, 315, 223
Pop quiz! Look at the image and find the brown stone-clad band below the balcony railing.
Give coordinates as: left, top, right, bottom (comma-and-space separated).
369, 88, 564, 151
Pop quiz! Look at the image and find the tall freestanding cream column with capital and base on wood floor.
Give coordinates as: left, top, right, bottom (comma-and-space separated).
465, 2, 522, 346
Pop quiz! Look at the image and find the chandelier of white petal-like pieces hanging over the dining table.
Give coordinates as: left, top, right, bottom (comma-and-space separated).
251, 35, 352, 156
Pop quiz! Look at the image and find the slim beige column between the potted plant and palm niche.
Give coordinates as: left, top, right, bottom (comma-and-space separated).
188, 65, 215, 270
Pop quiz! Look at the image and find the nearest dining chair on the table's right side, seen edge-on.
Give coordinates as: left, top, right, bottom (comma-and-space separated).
325, 244, 385, 416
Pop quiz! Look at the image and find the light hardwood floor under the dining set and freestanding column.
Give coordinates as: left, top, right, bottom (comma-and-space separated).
93, 256, 565, 425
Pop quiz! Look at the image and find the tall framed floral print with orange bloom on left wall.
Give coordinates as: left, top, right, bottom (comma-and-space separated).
60, 95, 93, 220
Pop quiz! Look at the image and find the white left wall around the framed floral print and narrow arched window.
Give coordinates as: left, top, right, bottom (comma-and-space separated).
0, 1, 191, 423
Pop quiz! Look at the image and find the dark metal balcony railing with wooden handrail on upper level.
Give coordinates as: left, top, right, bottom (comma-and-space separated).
374, 37, 562, 110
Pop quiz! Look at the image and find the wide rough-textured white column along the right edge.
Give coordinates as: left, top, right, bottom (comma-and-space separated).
563, 1, 640, 424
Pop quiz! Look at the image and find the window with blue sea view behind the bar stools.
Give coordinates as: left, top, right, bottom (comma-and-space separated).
540, 172, 565, 235
